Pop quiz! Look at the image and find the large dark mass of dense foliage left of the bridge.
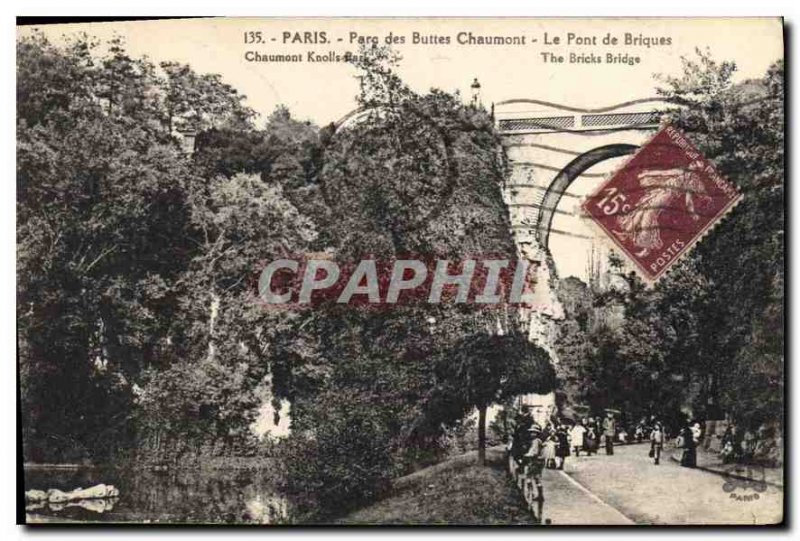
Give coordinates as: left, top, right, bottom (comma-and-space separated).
18, 36, 553, 516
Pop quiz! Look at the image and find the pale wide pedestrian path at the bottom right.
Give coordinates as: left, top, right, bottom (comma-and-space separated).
510, 443, 784, 526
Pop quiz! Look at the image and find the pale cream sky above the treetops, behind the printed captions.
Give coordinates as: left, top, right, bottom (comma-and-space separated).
18, 18, 783, 278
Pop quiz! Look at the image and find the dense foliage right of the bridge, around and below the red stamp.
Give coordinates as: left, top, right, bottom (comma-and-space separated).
560, 52, 785, 442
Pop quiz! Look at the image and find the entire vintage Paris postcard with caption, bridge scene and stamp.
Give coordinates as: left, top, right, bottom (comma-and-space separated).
16, 18, 786, 527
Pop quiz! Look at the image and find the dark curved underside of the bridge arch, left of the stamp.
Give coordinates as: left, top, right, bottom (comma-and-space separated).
536, 143, 639, 249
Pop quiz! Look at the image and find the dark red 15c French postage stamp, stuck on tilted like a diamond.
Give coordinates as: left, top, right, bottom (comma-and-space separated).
581, 125, 742, 283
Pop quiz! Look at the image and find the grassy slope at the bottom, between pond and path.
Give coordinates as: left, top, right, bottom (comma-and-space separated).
337, 450, 533, 525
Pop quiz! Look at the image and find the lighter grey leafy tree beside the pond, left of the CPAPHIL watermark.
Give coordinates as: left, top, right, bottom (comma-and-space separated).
134, 174, 316, 454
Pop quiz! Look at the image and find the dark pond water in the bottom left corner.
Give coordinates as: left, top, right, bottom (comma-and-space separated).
25, 467, 290, 524
